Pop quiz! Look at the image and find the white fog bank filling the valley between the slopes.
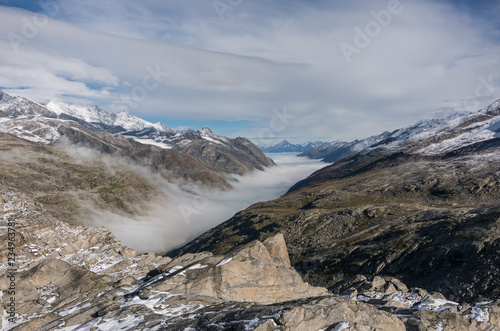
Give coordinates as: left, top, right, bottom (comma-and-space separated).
87, 153, 327, 253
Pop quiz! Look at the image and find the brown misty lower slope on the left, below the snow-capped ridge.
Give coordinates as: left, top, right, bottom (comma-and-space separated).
0, 119, 231, 223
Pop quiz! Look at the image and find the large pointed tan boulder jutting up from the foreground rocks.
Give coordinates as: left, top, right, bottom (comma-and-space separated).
149, 234, 328, 304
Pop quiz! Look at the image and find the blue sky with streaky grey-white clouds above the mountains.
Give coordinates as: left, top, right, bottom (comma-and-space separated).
0, 0, 500, 144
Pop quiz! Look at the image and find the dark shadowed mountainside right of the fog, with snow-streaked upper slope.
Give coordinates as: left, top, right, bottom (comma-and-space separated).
170, 102, 500, 301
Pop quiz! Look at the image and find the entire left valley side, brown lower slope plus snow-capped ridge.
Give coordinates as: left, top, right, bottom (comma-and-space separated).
0, 91, 274, 223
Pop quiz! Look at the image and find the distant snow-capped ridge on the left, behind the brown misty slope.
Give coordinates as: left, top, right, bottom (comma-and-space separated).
0, 91, 275, 175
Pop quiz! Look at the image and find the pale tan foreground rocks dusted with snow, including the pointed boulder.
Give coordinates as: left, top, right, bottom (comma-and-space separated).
0, 191, 500, 331
